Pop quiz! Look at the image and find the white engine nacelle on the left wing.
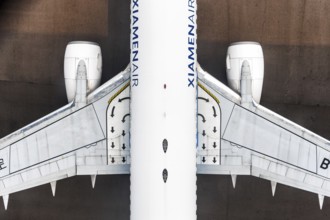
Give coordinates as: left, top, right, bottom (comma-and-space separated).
64, 41, 102, 102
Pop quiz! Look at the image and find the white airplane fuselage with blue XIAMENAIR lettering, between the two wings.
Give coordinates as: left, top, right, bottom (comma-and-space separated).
130, 0, 197, 220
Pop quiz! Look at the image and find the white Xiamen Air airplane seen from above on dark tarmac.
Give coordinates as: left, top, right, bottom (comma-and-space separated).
0, 0, 329, 219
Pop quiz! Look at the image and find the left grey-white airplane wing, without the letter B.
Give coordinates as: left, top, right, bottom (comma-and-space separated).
0, 68, 130, 207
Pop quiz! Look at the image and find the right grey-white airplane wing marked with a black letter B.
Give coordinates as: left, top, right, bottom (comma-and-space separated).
197, 65, 330, 207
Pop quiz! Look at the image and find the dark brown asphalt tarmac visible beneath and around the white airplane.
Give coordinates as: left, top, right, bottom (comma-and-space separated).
0, 0, 330, 220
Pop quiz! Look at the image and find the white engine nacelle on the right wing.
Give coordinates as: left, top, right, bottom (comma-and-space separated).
226, 41, 264, 103
